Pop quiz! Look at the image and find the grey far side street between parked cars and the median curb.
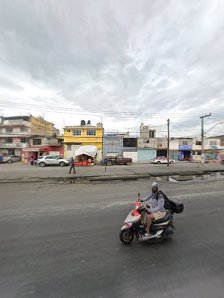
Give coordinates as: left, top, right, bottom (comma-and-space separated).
0, 161, 224, 180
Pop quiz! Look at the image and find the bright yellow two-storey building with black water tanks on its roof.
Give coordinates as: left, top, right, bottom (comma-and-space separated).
64, 120, 103, 161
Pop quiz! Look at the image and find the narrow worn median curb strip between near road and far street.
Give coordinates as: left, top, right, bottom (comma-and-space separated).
0, 169, 224, 184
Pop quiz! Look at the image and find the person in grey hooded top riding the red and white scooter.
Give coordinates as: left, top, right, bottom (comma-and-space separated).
140, 182, 166, 237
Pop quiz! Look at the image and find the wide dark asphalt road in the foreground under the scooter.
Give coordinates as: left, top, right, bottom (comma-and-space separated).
0, 181, 224, 298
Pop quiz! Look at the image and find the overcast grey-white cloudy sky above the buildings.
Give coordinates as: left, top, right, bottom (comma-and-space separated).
0, 0, 224, 136
